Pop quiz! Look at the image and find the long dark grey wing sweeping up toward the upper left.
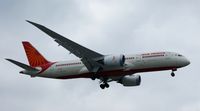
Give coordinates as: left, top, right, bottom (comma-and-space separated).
27, 20, 104, 72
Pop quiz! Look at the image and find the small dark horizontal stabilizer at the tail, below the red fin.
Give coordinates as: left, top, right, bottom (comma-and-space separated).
6, 59, 39, 71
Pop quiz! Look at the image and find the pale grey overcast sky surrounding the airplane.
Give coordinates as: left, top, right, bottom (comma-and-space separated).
0, 0, 200, 111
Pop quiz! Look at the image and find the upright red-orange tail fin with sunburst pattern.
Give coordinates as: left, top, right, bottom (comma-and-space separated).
22, 41, 50, 67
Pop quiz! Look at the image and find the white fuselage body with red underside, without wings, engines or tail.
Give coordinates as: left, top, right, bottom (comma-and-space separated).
21, 52, 189, 79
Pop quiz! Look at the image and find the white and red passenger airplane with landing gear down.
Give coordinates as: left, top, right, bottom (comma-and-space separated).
6, 20, 190, 89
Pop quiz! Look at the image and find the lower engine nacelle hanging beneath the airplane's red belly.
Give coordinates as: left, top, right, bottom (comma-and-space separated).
119, 75, 141, 86
